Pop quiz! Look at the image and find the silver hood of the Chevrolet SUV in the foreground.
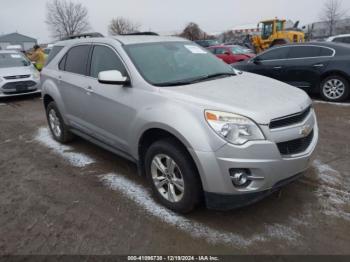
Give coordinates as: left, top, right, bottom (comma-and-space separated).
161, 73, 311, 125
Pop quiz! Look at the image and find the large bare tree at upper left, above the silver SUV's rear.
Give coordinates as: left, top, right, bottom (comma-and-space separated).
45, 0, 90, 39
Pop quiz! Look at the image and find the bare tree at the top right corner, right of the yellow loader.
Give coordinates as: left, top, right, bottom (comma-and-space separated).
320, 0, 346, 36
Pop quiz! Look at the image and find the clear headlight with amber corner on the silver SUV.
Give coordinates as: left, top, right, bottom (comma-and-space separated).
205, 110, 265, 145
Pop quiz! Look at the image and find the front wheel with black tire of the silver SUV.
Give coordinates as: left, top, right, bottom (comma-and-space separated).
145, 139, 202, 214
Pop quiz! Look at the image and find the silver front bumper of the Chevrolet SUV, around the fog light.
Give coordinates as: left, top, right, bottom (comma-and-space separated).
191, 111, 318, 209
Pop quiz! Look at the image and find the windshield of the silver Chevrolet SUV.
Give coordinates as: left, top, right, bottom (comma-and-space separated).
124, 42, 234, 86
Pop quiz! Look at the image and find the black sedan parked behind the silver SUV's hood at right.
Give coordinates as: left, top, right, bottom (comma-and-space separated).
233, 43, 350, 102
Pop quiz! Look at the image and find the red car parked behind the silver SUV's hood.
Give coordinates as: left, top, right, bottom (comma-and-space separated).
208, 45, 255, 64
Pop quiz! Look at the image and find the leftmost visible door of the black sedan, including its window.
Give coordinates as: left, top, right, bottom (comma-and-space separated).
249, 46, 289, 81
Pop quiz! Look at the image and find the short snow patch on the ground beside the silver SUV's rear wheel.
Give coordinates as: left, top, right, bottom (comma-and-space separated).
34, 127, 95, 167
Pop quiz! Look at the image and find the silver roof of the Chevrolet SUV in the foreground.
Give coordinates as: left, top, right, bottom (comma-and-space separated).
56, 35, 190, 46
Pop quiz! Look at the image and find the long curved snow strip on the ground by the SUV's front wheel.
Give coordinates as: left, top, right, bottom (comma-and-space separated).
100, 173, 300, 247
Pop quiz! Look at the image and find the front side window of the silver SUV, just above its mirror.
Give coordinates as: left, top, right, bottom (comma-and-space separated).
90, 46, 126, 78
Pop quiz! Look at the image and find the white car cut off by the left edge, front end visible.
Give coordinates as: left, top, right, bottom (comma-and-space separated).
0, 51, 41, 97
